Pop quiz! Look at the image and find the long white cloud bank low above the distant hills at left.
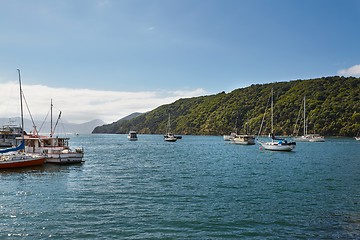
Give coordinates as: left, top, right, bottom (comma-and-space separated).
0, 82, 207, 123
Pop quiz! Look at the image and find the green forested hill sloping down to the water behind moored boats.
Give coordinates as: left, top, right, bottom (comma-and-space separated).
93, 76, 360, 137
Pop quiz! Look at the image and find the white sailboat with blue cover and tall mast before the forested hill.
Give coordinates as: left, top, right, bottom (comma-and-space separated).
258, 89, 296, 151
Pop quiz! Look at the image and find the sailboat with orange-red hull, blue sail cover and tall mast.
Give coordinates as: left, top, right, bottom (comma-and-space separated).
0, 69, 45, 169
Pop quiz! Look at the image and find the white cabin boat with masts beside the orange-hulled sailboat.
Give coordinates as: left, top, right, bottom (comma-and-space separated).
19, 100, 84, 164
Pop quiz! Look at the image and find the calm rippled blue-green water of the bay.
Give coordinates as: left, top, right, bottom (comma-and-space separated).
0, 135, 360, 239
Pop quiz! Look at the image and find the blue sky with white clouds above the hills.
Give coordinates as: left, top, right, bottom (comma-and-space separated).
0, 0, 360, 123
